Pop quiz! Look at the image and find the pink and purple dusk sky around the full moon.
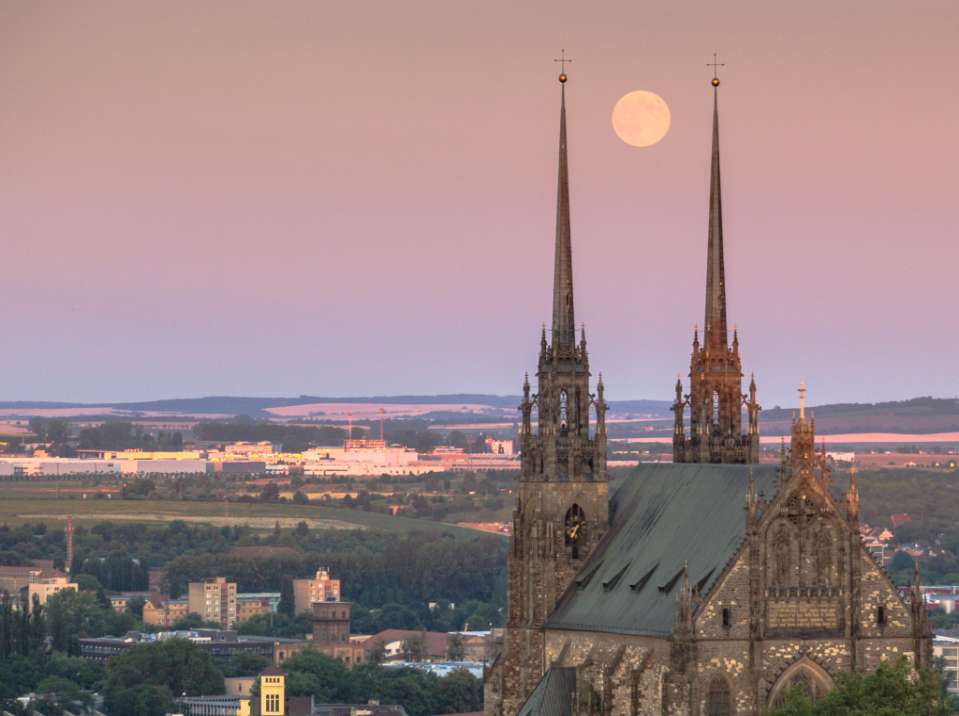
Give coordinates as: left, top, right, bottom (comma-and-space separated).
0, 0, 959, 406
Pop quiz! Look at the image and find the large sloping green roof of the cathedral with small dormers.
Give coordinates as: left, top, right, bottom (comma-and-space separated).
546, 463, 779, 637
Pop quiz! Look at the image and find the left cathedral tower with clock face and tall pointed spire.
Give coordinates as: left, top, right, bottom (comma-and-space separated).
486, 67, 609, 716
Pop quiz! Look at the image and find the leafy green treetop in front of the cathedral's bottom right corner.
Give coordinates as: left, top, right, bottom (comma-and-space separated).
770, 657, 952, 716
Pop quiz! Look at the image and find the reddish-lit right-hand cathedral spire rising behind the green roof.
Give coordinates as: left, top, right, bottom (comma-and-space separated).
673, 75, 760, 463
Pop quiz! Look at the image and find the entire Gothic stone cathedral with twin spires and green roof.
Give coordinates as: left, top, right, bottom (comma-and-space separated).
485, 73, 932, 716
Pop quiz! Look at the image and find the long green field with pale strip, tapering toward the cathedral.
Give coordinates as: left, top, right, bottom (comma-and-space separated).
0, 483, 488, 535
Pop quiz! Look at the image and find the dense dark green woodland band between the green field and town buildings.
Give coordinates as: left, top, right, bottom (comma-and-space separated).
0, 521, 506, 635
